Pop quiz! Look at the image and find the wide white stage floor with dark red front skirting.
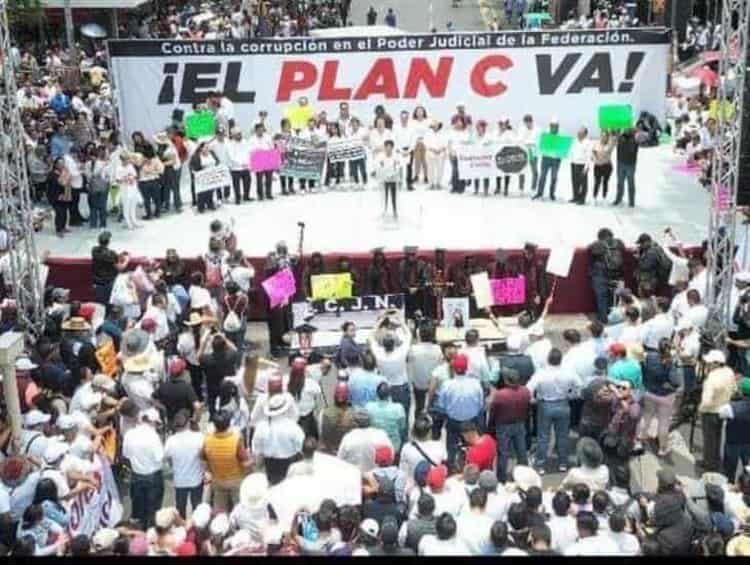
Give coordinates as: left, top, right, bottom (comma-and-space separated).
37, 146, 709, 319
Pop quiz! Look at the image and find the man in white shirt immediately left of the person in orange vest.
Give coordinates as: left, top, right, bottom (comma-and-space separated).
164, 410, 205, 519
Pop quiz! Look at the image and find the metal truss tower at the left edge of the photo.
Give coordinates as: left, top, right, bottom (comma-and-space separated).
0, 0, 44, 335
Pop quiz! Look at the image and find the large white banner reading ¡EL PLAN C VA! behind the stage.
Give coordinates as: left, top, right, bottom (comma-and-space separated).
108, 28, 670, 142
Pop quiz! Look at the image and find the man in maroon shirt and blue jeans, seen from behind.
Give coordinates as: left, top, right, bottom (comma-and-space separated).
489, 369, 531, 483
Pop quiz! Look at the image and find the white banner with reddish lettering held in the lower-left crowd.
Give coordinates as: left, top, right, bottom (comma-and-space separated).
68, 455, 122, 537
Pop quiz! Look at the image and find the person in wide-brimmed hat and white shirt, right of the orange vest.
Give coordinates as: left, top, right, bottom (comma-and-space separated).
252, 394, 305, 486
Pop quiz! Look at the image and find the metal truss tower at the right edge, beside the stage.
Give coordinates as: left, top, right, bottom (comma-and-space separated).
706, 0, 750, 347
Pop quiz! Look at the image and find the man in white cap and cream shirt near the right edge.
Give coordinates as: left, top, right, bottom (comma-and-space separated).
698, 349, 737, 472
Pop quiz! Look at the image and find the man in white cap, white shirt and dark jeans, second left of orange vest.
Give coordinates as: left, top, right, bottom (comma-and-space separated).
122, 408, 164, 529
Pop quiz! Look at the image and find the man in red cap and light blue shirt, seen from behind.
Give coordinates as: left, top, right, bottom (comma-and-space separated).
439, 353, 484, 467
